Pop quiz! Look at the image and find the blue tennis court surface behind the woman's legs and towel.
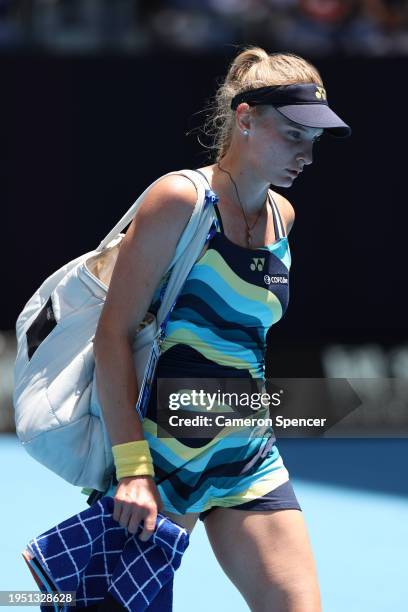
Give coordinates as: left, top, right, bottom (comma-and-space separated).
0, 435, 408, 612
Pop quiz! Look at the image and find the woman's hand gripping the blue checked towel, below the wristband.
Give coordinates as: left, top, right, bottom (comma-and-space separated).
113, 476, 163, 542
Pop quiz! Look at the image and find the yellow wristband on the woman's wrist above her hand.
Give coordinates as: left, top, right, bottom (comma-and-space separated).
112, 440, 154, 480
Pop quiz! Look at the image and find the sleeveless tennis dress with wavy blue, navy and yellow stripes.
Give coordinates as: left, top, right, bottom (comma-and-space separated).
143, 179, 300, 520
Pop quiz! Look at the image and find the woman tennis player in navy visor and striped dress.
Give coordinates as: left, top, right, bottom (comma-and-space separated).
94, 48, 350, 612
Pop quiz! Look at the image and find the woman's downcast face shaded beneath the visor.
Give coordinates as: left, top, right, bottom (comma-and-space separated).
241, 106, 323, 187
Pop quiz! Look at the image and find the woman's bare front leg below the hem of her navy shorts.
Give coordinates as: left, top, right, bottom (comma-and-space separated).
204, 508, 321, 612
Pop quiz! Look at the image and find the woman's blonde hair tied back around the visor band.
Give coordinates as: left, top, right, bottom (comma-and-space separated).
203, 47, 323, 161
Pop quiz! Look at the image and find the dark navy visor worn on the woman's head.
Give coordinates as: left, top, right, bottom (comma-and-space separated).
231, 83, 351, 138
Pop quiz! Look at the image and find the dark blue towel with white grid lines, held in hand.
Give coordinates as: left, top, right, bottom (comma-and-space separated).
27, 496, 189, 612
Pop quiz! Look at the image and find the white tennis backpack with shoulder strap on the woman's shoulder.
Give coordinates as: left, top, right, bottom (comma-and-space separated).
13, 170, 213, 491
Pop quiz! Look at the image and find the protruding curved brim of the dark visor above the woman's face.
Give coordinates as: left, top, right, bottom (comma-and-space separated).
275, 104, 351, 138
